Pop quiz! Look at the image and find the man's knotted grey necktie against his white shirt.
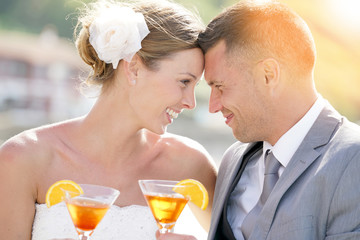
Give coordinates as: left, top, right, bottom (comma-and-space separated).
241, 149, 281, 239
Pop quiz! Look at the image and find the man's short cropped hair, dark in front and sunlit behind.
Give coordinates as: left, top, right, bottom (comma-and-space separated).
198, 0, 316, 74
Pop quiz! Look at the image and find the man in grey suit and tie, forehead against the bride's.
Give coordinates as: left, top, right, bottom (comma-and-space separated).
158, 0, 360, 240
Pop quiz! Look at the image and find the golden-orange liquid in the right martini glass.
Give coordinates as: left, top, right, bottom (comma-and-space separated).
144, 194, 189, 229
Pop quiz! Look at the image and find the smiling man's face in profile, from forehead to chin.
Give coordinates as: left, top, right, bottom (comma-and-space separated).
205, 41, 266, 142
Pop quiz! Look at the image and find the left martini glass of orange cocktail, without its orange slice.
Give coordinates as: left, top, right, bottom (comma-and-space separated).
64, 184, 120, 240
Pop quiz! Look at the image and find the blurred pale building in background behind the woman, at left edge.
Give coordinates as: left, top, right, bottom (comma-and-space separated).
0, 28, 91, 140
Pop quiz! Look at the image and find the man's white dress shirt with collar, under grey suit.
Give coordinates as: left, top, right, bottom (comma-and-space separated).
227, 96, 325, 240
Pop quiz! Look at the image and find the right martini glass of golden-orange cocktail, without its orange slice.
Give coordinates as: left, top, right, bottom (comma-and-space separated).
139, 180, 189, 233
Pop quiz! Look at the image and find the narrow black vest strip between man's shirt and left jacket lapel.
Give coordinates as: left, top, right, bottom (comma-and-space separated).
215, 142, 263, 240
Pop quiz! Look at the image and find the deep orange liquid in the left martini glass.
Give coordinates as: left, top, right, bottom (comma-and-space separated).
67, 197, 110, 231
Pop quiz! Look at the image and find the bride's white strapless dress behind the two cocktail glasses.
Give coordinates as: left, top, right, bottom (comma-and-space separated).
32, 202, 207, 240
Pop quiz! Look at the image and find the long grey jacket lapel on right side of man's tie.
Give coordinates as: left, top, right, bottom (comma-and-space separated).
250, 106, 340, 239
